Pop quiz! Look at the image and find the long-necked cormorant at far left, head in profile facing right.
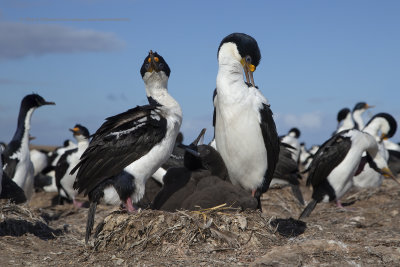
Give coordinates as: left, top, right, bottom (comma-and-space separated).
3, 94, 55, 201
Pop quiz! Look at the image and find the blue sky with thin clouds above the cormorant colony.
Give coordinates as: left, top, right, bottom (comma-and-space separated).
0, 0, 400, 149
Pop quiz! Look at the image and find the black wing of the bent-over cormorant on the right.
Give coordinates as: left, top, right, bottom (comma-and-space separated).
307, 130, 351, 188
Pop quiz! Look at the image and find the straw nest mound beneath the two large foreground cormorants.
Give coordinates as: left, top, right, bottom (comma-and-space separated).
94, 207, 304, 255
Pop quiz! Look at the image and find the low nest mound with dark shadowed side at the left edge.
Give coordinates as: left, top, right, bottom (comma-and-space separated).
0, 203, 63, 240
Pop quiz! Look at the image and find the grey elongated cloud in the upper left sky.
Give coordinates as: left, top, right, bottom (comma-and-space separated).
0, 22, 125, 59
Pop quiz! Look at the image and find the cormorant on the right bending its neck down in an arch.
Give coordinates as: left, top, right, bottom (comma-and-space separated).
299, 129, 397, 219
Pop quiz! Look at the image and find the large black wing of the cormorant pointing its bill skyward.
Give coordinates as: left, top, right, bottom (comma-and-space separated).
71, 105, 167, 195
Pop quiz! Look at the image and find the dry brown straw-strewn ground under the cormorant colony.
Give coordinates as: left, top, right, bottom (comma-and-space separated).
0, 177, 400, 266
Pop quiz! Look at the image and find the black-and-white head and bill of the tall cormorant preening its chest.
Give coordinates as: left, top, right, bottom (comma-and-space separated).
218, 33, 261, 87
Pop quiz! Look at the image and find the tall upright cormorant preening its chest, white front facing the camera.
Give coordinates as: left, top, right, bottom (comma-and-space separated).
214, 33, 279, 209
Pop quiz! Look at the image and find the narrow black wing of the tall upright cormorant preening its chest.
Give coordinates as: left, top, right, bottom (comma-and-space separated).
260, 104, 280, 193
